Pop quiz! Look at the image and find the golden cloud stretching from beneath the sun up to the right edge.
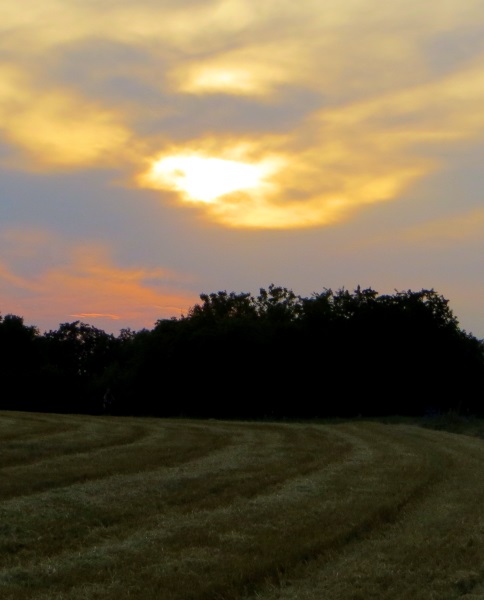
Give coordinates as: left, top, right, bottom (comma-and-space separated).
139, 45, 484, 228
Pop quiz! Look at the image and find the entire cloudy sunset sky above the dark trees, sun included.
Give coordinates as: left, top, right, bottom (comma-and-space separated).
0, 0, 484, 338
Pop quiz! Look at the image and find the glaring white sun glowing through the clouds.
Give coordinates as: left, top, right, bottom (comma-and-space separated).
148, 154, 268, 203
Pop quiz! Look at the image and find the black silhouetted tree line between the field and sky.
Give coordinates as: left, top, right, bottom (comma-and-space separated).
0, 284, 484, 419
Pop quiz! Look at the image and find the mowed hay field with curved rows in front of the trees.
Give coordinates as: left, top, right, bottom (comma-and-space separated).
0, 412, 484, 600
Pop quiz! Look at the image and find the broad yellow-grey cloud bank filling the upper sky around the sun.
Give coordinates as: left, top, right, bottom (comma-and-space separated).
0, 0, 484, 229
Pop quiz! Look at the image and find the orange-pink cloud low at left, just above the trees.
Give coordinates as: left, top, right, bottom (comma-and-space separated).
0, 230, 197, 332
